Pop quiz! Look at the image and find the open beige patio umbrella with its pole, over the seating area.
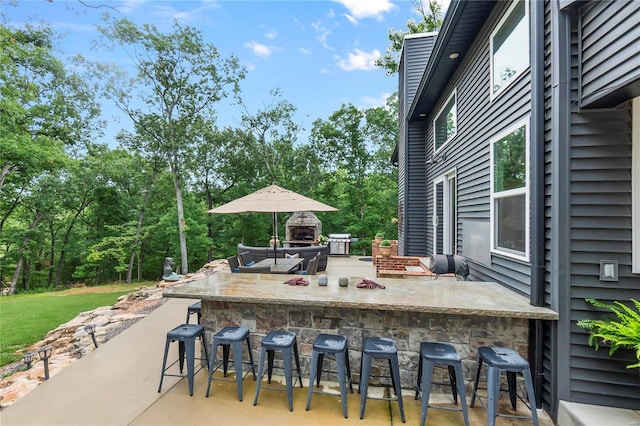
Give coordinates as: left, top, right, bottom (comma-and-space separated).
207, 185, 338, 263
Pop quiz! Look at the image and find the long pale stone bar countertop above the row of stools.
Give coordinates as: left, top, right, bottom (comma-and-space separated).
163, 273, 558, 320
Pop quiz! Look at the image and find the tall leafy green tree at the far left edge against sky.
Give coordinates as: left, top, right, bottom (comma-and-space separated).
0, 25, 99, 294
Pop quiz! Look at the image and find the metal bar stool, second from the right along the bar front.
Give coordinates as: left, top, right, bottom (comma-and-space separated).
415, 342, 469, 426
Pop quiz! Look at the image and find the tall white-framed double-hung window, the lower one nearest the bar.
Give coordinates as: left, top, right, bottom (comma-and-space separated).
491, 122, 529, 260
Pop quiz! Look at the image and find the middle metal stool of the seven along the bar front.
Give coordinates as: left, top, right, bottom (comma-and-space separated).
306, 334, 353, 419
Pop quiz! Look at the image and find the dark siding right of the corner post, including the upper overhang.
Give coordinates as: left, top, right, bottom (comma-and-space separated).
560, 1, 640, 409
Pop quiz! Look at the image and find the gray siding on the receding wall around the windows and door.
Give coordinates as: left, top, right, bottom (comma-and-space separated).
420, 2, 531, 294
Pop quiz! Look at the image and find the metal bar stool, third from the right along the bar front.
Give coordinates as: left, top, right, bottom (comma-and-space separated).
358, 337, 406, 423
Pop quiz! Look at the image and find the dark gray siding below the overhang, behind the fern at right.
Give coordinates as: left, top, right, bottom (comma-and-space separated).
565, 103, 640, 408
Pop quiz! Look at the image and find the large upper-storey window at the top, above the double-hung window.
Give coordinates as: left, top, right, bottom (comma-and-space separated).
491, 0, 529, 97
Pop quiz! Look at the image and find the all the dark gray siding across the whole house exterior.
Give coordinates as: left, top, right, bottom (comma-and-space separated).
400, 0, 640, 417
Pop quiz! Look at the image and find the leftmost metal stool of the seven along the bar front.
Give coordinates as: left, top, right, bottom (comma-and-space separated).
158, 324, 209, 396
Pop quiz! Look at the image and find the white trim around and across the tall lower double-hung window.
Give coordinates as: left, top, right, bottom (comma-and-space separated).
489, 118, 531, 262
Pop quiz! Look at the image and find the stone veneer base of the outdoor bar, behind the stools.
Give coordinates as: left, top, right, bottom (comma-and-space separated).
202, 300, 529, 392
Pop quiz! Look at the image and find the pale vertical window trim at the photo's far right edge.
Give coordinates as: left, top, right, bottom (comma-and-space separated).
631, 97, 640, 274
